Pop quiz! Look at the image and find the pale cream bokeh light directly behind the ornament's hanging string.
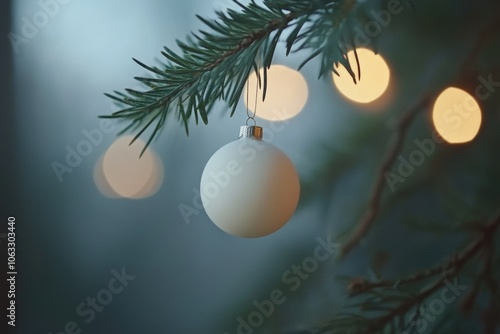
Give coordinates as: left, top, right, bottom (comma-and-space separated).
243, 65, 309, 121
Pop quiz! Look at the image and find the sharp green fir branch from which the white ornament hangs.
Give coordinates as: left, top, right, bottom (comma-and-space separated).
101, 0, 376, 153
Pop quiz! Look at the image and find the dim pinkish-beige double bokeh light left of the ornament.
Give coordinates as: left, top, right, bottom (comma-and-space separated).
94, 136, 167, 199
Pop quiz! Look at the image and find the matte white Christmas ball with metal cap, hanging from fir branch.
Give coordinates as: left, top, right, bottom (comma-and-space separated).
200, 126, 300, 238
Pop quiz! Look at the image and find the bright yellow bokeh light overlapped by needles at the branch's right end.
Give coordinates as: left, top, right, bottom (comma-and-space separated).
332, 48, 391, 103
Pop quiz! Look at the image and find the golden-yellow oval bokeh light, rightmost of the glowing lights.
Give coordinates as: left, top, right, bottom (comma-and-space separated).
432, 87, 482, 144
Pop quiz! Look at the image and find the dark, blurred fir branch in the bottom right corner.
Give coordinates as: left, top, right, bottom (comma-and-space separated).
313, 215, 500, 334
